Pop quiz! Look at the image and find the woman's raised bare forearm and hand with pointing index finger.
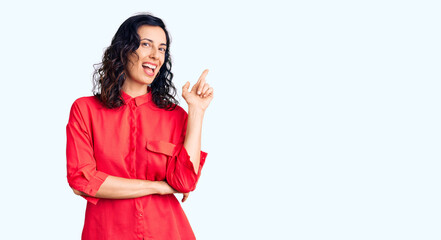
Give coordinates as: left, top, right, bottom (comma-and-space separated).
182, 69, 213, 174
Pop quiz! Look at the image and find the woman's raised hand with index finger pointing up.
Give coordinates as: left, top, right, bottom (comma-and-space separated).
182, 69, 213, 111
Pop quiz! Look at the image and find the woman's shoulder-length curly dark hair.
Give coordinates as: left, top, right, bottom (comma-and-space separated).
92, 13, 178, 110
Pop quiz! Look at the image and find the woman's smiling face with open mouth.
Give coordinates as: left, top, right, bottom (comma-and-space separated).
126, 25, 167, 85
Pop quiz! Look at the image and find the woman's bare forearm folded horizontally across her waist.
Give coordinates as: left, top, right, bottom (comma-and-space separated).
73, 176, 176, 199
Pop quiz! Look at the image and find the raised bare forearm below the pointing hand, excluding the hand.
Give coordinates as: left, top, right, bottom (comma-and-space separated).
184, 107, 205, 174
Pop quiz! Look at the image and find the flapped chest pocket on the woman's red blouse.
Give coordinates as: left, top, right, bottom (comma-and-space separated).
145, 140, 176, 181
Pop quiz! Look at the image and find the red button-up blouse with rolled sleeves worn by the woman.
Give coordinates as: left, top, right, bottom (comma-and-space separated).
66, 91, 207, 240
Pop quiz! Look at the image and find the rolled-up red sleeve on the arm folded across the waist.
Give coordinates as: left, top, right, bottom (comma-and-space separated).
66, 102, 108, 204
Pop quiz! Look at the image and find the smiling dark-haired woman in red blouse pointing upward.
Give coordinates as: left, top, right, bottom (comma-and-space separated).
66, 14, 213, 240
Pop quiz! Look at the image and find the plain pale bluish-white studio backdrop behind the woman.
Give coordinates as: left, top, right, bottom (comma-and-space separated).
0, 1, 441, 240
